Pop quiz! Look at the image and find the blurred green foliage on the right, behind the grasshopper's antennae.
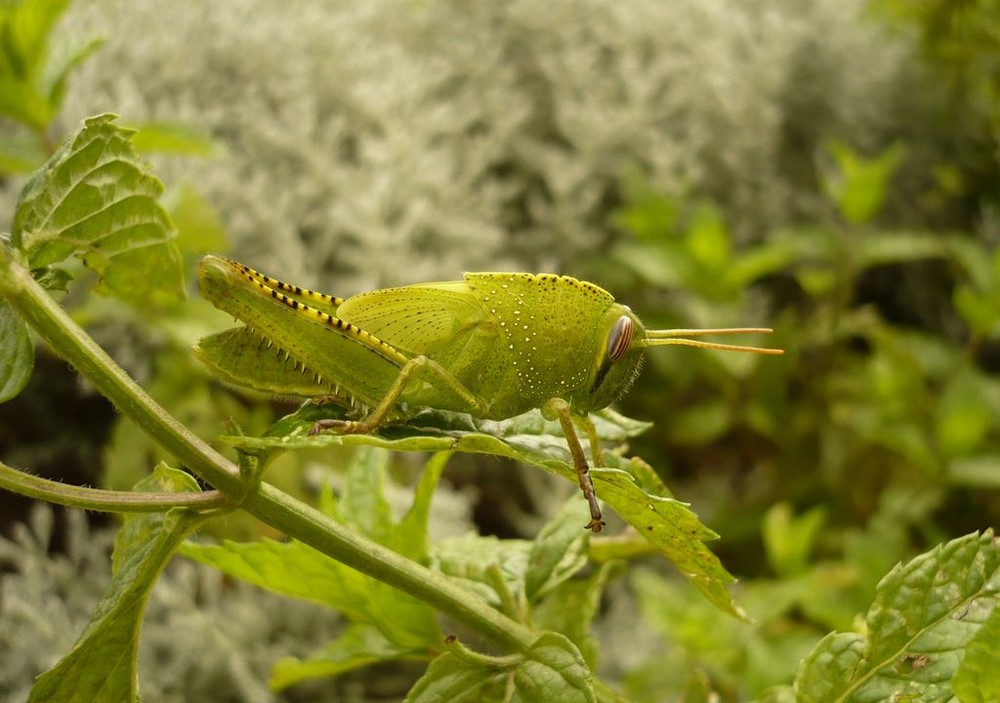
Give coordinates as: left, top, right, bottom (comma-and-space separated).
592, 53, 1000, 701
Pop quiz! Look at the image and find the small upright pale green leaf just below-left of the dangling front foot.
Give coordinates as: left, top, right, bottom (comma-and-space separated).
524, 500, 590, 602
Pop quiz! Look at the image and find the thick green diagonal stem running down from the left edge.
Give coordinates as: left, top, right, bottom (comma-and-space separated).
0, 245, 534, 650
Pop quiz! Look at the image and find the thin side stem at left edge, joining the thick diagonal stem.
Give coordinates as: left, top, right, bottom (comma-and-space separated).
0, 461, 229, 513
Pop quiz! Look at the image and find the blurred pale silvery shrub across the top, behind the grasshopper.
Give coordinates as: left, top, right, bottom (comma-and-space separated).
54, 0, 909, 294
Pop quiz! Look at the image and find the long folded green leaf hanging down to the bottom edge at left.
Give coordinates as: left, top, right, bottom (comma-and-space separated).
28, 465, 206, 703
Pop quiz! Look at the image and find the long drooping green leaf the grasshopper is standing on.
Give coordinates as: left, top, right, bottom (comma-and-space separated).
222, 406, 743, 617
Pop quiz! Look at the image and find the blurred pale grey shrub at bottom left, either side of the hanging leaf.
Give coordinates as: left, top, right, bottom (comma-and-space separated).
0, 504, 343, 703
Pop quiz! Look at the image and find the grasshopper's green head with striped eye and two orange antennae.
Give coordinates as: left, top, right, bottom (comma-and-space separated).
574, 304, 784, 412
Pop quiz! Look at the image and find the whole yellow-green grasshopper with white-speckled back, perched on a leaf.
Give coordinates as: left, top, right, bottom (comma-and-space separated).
195, 256, 782, 533
